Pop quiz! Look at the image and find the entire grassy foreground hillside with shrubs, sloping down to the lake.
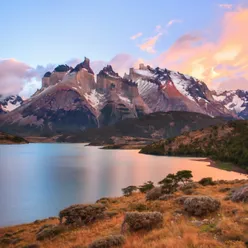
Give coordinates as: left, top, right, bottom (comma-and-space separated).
0, 171, 248, 248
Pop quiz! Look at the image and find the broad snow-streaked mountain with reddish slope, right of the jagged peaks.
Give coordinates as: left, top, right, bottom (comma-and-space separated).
125, 64, 237, 119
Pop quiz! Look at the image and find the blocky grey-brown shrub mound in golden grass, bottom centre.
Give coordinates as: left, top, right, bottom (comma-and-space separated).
122, 212, 163, 232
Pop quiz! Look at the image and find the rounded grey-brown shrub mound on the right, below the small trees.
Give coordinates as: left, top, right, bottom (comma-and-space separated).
183, 196, 220, 216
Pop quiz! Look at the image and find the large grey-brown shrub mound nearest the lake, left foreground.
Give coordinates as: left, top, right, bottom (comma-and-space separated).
59, 203, 106, 225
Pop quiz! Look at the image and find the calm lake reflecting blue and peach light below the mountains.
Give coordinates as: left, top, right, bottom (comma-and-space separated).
0, 144, 246, 226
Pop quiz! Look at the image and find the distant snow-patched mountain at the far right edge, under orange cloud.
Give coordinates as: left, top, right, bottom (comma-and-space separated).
213, 90, 248, 119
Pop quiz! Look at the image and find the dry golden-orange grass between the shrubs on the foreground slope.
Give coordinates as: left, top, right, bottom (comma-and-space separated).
0, 181, 248, 248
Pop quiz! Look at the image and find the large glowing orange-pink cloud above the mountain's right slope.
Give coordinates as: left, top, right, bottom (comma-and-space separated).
154, 9, 248, 89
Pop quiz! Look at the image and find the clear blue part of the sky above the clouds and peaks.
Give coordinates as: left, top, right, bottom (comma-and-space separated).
0, 0, 235, 66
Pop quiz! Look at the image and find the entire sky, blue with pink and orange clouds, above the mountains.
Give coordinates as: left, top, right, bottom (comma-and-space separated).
0, 0, 248, 97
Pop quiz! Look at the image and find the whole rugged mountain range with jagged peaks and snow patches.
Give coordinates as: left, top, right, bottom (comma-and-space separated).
0, 58, 248, 136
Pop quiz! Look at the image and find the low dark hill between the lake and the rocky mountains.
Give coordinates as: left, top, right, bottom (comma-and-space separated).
58, 111, 225, 148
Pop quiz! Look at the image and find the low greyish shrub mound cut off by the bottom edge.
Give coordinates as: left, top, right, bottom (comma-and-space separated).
89, 235, 125, 248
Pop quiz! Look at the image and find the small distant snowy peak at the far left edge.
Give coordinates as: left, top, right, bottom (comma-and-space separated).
0, 95, 23, 114
